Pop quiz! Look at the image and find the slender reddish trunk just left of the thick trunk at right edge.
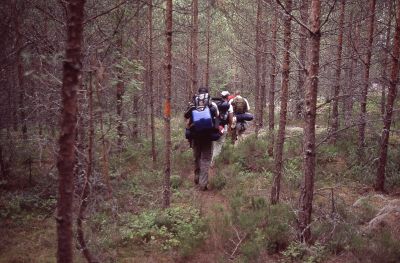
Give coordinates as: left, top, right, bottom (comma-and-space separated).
358, 0, 376, 161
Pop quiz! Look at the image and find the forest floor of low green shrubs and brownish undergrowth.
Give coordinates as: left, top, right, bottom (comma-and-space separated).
0, 120, 400, 263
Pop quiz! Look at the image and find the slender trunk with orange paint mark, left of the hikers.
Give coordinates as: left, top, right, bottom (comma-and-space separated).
163, 0, 172, 208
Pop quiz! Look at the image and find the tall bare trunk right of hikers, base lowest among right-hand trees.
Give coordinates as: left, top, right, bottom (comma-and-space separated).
299, 0, 321, 242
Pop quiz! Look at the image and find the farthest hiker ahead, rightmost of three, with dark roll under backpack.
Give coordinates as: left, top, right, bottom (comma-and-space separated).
229, 90, 253, 143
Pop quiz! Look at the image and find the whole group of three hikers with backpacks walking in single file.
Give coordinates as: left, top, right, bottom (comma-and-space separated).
184, 87, 253, 191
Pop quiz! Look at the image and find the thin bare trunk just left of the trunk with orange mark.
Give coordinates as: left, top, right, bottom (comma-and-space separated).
148, 0, 157, 167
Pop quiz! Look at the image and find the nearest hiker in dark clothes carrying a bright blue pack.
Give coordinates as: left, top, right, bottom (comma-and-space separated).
184, 87, 220, 191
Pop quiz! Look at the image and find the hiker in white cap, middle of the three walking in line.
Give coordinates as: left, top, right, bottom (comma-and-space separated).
211, 90, 233, 163
